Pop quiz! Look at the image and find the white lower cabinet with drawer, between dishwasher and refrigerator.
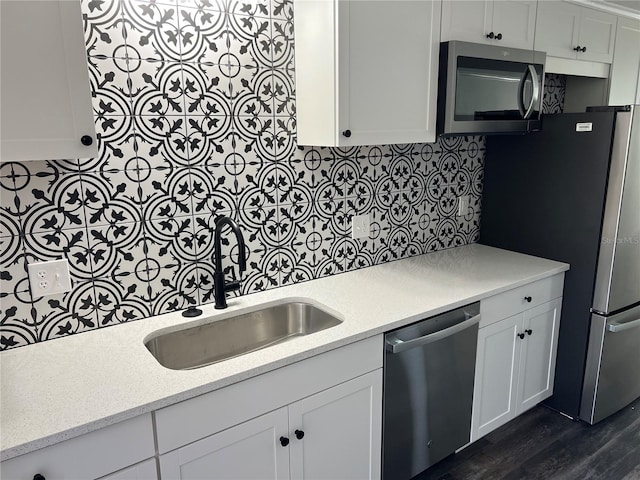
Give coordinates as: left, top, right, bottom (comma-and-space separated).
471, 275, 562, 442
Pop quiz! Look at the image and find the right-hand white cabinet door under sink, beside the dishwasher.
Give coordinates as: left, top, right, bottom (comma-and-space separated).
289, 370, 382, 480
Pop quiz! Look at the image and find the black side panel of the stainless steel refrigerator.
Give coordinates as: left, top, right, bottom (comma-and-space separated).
480, 113, 614, 417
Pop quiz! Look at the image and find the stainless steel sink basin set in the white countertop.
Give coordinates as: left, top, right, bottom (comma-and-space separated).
145, 302, 342, 370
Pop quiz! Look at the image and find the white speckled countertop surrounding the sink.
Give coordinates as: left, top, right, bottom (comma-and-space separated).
0, 244, 569, 460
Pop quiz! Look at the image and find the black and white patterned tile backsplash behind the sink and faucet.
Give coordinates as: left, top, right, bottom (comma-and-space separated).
0, 0, 498, 349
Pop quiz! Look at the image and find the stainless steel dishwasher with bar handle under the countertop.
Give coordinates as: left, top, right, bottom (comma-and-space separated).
383, 302, 480, 480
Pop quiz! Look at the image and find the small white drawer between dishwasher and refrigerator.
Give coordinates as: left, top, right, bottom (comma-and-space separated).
480, 273, 564, 328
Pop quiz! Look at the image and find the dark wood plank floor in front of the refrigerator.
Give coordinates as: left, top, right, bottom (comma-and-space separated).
414, 399, 640, 480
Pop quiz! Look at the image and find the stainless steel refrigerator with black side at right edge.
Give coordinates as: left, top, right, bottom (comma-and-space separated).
480, 106, 640, 423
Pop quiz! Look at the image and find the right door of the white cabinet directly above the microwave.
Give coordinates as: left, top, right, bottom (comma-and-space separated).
491, 0, 538, 50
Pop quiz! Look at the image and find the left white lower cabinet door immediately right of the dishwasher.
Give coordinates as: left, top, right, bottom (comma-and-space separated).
471, 314, 522, 441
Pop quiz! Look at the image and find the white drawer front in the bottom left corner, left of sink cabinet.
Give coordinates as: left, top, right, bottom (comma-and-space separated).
0, 413, 155, 480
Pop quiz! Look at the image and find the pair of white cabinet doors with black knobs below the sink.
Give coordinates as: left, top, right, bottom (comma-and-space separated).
160, 369, 382, 480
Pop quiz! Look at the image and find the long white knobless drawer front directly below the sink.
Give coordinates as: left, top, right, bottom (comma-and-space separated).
155, 335, 384, 454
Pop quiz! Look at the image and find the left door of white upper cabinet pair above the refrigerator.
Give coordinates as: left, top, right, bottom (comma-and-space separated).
534, 1, 581, 59
